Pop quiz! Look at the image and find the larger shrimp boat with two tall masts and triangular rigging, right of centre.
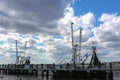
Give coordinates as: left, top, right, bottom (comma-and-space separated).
53, 23, 113, 80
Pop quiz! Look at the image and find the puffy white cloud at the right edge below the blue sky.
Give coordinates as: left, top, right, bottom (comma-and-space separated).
93, 14, 120, 48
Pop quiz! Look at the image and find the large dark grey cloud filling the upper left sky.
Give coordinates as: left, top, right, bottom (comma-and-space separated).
0, 0, 68, 35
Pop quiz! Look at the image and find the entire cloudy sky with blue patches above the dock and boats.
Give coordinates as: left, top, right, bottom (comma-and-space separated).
0, 0, 120, 64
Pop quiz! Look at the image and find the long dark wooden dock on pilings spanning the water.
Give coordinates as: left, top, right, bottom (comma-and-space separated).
0, 64, 120, 80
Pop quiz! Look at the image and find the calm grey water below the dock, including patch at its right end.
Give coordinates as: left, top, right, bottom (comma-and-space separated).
0, 71, 120, 80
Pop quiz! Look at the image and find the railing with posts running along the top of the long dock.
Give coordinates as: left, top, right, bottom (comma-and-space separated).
0, 63, 120, 70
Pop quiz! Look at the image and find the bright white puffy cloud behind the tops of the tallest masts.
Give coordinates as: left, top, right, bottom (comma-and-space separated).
58, 7, 95, 42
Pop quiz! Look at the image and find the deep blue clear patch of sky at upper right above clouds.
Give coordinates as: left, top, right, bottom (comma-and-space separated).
72, 0, 120, 17
